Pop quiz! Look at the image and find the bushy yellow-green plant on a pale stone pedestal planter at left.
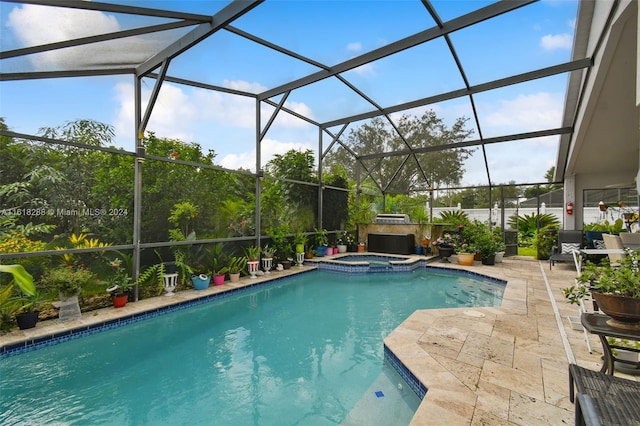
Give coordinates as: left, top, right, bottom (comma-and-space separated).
42, 264, 96, 321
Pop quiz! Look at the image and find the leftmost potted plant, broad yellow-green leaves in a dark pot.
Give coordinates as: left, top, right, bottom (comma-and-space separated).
0, 264, 41, 330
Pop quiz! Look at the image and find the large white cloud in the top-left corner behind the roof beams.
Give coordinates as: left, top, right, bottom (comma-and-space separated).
7, 4, 165, 70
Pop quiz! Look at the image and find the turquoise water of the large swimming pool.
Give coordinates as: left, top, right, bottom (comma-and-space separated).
0, 270, 504, 425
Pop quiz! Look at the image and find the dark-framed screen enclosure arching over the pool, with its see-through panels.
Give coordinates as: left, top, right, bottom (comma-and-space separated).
0, 0, 639, 296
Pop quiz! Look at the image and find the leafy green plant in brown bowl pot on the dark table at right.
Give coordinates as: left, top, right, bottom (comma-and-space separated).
562, 249, 640, 324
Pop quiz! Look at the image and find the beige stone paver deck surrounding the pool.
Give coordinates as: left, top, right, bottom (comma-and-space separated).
0, 257, 629, 426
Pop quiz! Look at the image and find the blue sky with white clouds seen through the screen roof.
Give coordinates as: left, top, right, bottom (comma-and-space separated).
0, 0, 577, 185
